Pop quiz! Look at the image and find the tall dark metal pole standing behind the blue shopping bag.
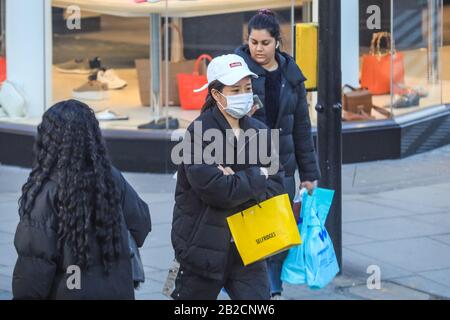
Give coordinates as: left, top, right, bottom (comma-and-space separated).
316, 0, 342, 270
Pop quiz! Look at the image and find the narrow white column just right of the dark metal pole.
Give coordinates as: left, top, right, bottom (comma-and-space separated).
341, 0, 359, 87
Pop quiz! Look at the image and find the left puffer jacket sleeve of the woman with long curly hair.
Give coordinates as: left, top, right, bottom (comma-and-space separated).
12, 191, 58, 299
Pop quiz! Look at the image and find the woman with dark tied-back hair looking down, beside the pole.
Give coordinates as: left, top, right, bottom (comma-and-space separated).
235, 9, 320, 299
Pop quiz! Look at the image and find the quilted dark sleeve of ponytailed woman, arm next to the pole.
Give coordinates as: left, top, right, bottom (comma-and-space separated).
294, 82, 320, 181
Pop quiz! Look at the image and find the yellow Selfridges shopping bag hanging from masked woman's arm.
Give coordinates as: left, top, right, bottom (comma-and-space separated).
227, 194, 301, 266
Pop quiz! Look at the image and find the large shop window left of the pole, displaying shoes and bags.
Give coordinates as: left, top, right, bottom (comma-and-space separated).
48, 0, 302, 129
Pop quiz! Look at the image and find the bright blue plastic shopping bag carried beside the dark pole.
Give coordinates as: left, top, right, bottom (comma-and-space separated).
281, 188, 339, 289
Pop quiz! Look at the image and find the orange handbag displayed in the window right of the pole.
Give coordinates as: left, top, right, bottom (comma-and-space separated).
361, 32, 405, 95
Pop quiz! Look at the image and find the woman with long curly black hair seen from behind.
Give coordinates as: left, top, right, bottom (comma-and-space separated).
12, 100, 151, 299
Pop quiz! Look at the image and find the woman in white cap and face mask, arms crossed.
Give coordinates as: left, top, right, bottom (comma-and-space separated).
167, 55, 284, 300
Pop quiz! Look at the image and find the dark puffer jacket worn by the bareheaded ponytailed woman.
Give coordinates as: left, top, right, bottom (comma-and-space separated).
235, 45, 320, 181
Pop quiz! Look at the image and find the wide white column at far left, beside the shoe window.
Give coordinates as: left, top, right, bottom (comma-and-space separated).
6, 0, 52, 117
